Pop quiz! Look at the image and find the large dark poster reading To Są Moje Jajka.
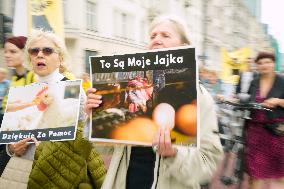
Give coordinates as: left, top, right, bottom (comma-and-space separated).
90, 47, 198, 147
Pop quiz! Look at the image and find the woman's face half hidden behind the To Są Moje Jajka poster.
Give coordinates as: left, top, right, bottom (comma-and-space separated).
149, 21, 183, 49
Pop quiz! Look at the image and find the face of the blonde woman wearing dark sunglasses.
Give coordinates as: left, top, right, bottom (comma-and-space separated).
29, 38, 61, 76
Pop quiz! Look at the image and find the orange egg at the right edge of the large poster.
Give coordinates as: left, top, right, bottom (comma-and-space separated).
176, 104, 197, 136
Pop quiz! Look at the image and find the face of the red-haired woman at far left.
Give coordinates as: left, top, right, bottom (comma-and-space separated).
4, 42, 24, 68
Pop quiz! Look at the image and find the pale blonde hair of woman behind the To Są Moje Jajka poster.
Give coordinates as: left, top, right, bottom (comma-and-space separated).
149, 15, 190, 45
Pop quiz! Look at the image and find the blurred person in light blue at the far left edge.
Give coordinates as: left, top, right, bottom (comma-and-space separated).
0, 68, 10, 125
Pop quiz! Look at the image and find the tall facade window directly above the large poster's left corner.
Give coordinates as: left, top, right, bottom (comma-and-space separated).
86, 1, 97, 31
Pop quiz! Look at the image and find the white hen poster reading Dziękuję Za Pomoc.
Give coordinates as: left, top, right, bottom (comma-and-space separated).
0, 80, 81, 143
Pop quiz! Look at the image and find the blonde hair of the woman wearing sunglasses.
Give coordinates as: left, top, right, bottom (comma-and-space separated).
24, 29, 69, 70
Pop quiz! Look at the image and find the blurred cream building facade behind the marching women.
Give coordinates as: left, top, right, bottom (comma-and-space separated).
0, 0, 271, 76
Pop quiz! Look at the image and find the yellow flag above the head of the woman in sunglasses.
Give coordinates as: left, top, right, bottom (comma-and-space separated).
28, 0, 64, 39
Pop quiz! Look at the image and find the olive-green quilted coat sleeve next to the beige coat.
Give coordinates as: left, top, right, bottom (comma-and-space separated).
88, 149, 106, 188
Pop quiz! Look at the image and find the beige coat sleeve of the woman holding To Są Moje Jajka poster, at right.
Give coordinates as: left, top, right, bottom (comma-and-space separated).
161, 87, 223, 186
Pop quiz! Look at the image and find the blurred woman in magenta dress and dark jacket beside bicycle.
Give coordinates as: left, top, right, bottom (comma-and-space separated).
245, 52, 284, 189
